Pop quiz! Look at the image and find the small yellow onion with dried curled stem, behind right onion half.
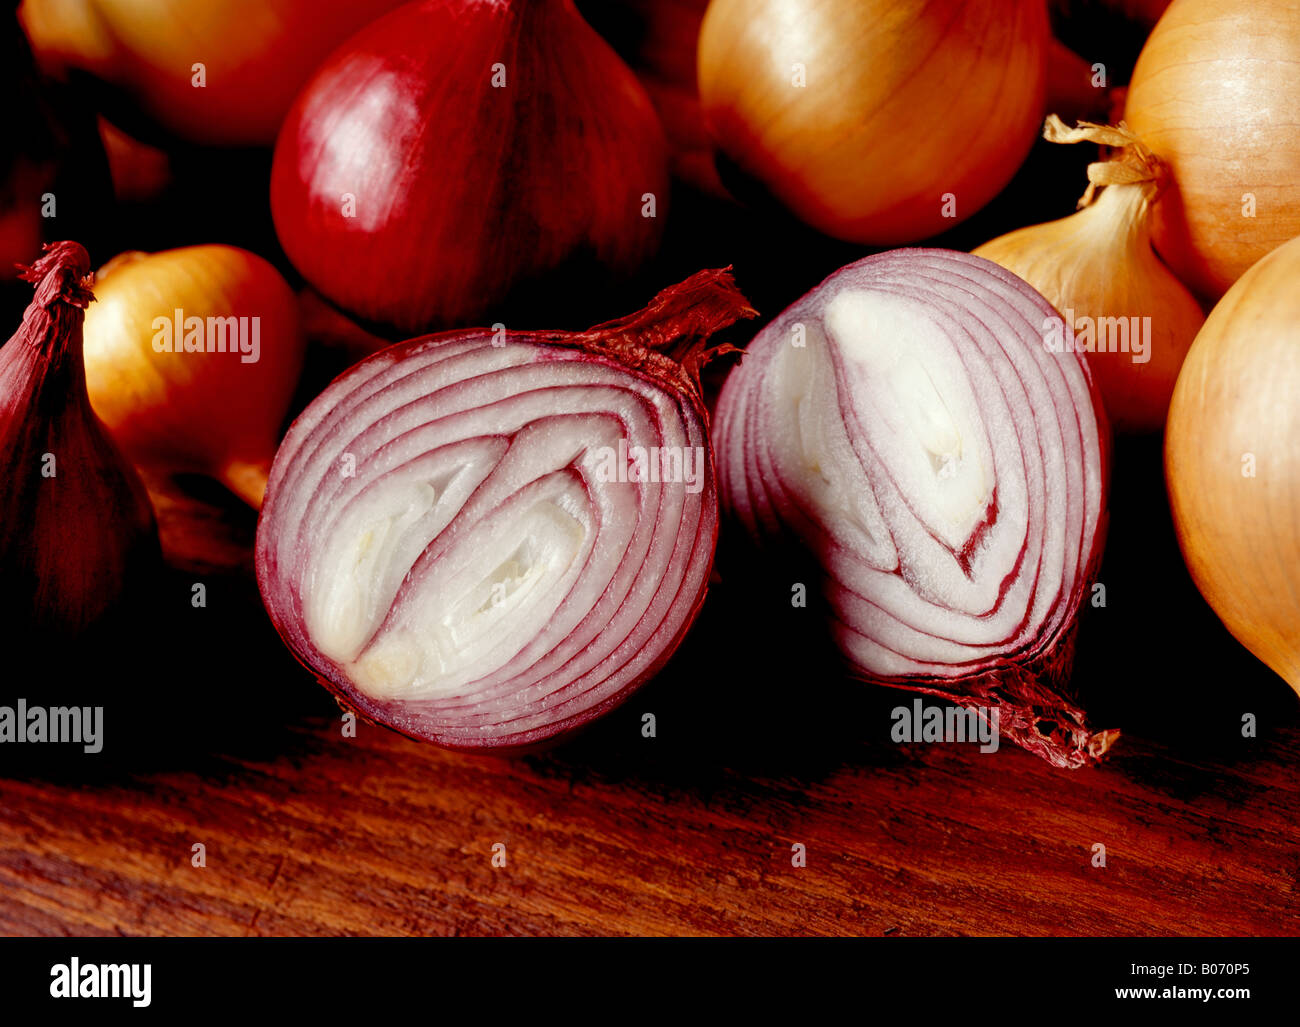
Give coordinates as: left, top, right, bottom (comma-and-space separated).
972, 117, 1205, 433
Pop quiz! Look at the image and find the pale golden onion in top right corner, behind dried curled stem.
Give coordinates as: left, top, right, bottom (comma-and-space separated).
1125, 0, 1300, 302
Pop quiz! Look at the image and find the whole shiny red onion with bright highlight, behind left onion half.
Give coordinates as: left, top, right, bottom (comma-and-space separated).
270, 0, 668, 332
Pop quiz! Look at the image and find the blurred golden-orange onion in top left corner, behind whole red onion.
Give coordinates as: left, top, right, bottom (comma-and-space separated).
20, 0, 402, 146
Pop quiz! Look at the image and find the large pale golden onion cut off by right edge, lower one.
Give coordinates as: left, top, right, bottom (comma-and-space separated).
1165, 239, 1300, 693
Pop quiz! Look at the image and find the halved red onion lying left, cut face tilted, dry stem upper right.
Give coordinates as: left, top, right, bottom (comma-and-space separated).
256, 272, 753, 750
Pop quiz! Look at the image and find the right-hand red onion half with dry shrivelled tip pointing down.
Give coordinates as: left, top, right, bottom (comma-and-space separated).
715, 250, 1118, 767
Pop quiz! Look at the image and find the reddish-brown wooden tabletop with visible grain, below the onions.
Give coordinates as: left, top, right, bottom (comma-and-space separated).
0, 691, 1300, 935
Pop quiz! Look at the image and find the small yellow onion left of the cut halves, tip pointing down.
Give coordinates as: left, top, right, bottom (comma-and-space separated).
86, 246, 304, 507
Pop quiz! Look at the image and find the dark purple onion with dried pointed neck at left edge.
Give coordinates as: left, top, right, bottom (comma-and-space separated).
0, 242, 160, 639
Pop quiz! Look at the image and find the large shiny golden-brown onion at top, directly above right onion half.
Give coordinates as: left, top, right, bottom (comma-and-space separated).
699, 0, 1049, 246
